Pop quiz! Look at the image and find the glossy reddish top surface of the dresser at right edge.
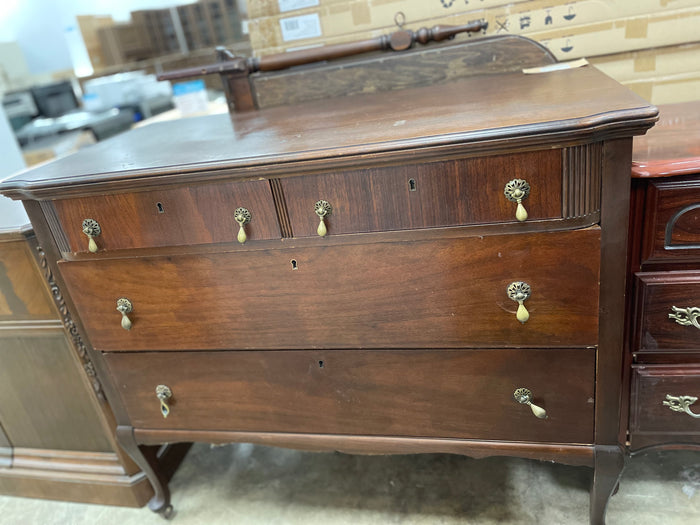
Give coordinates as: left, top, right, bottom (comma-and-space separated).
632, 101, 700, 178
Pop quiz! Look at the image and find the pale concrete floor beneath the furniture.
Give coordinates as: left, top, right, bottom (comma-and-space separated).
0, 444, 700, 525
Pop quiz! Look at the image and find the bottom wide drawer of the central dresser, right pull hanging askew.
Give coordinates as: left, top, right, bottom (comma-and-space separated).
105, 349, 595, 443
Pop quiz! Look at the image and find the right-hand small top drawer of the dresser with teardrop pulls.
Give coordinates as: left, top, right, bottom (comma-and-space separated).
281, 150, 562, 237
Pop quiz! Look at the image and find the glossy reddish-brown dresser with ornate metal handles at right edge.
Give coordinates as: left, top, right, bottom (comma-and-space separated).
628, 102, 700, 453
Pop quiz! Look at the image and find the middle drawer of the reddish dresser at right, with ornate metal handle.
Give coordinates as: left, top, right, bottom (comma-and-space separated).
632, 271, 700, 352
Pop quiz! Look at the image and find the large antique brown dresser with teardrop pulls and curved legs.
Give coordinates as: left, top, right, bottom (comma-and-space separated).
0, 62, 657, 524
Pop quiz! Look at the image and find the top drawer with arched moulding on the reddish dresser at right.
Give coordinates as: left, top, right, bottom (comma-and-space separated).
642, 177, 700, 263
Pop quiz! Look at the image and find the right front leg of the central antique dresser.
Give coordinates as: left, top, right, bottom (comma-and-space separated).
590, 445, 625, 525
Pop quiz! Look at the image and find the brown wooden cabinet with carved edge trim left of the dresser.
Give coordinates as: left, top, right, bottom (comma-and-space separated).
0, 229, 190, 507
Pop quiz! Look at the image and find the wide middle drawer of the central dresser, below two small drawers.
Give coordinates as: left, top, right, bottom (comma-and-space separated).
60, 228, 600, 351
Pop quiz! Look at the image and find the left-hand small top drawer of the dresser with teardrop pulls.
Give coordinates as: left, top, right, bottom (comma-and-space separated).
53, 180, 280, 253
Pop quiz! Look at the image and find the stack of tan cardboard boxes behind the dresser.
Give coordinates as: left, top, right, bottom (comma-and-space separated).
248, 0, 700, 104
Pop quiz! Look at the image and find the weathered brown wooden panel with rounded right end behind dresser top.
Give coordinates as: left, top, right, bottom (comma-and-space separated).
250, 35, 555, 108
